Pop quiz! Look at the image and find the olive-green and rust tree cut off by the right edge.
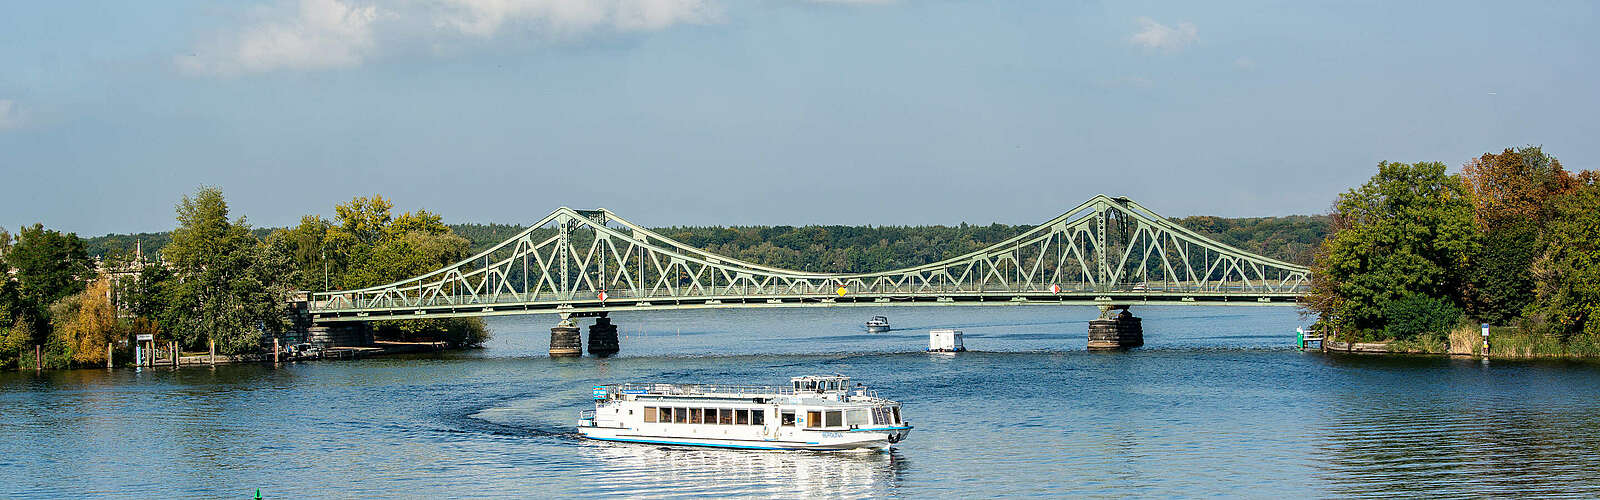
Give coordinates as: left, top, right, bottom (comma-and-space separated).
1533, 177, 1600, 338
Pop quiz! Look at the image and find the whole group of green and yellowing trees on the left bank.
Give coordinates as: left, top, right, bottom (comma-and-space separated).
0, 188, 488, 369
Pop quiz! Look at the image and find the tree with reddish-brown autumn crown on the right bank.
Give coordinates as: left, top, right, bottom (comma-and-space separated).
1461, 146, 1578, 324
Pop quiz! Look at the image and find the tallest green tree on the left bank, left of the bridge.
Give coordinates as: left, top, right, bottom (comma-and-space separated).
162, 188, 288, 354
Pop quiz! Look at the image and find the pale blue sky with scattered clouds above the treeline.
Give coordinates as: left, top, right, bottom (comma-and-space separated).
0, 0, 1600, 236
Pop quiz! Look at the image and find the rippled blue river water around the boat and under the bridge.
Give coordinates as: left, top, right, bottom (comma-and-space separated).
0, 306, 1600, 498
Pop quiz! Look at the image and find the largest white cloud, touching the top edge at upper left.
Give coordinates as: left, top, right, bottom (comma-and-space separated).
176, 0, 722, 75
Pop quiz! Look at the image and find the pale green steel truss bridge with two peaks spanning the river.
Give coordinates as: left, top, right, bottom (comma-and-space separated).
307, 196, 1310, 322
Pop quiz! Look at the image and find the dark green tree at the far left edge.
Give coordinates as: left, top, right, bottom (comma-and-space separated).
5, 224, 94, 336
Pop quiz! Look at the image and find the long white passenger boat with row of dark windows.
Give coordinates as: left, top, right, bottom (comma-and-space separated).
578, 375, 910, 450
